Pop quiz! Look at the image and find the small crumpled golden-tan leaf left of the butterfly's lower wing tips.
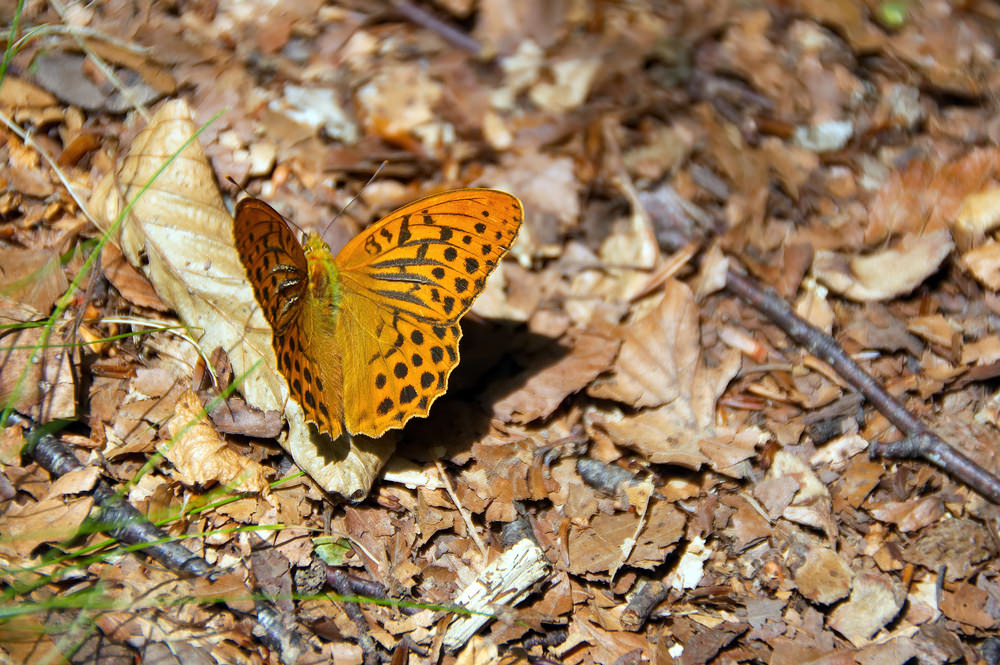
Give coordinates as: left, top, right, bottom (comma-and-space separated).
163, 390, 270, 495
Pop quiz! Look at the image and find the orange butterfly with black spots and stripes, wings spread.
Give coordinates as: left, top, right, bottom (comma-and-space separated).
233, 188, 524, 439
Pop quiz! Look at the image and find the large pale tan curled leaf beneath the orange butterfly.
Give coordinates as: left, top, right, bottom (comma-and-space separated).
90, 100, 394, 498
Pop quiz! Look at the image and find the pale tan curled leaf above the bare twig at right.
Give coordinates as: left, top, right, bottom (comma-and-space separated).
813, 230, 954, 302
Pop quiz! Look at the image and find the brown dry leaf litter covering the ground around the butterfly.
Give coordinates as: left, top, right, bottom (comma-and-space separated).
0, 0, 1000, 665
